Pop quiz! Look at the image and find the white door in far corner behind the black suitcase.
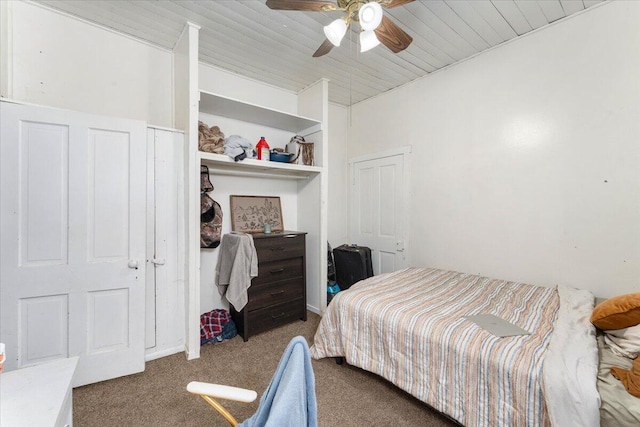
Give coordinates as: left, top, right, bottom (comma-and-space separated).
349, 153, 407, 274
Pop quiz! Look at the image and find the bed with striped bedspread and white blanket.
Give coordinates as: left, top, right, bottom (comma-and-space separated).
311, 268, 640, 427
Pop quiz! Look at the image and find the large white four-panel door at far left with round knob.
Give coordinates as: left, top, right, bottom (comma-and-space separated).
0, 102, 146, 386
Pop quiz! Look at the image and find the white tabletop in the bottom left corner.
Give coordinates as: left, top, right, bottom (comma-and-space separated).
0, 356, 78, 427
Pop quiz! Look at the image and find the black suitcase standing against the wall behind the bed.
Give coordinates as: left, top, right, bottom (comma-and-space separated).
333, 245, 373, 290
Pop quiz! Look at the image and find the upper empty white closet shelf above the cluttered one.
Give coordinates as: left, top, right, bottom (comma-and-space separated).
200, 91, 322, 136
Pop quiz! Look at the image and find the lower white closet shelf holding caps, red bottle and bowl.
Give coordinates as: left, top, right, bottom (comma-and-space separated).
198, 151, 322, 178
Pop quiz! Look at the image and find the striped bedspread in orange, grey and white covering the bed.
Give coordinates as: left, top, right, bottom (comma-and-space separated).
311, 268, 559, 427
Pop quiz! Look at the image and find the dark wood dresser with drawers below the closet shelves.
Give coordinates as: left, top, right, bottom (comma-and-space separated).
230, 231, 307, 341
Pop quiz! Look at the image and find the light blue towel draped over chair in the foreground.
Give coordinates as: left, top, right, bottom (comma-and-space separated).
238, 336, 318, 427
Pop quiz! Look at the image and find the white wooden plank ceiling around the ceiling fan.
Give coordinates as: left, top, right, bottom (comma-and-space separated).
36, 0, 602, 105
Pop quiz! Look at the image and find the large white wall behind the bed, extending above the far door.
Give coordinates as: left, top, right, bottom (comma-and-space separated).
348, 1, 640, 296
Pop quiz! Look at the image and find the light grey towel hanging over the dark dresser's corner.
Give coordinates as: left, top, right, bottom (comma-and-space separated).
216, 233, 258, 311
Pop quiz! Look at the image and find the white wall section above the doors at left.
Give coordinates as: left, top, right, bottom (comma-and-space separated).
2, 1, 173, 127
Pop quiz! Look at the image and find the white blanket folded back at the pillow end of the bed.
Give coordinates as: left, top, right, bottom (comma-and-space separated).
543, 286, 600, 427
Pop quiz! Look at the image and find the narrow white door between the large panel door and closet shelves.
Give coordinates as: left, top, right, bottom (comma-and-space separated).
145, 128, 186, 360
